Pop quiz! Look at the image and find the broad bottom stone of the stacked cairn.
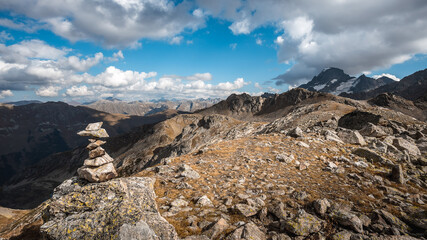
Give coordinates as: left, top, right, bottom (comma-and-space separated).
77, 163, 117, 182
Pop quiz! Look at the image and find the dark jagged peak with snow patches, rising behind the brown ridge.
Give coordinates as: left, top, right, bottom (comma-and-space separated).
299, 67, 395, 95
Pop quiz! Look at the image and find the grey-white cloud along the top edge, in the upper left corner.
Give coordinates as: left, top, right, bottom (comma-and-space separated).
0, 0, 205, 47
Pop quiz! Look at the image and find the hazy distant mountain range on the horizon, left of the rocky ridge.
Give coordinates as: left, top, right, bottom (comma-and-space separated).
84, 99, 219, 116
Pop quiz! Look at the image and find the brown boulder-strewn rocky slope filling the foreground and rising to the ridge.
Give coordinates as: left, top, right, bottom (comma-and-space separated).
0, 89, 427, 239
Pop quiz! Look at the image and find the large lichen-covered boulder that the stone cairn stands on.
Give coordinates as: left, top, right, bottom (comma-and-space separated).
40, 177, 178, 240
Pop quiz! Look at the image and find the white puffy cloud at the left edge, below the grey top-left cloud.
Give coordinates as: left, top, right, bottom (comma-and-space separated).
0, 40, 104, 90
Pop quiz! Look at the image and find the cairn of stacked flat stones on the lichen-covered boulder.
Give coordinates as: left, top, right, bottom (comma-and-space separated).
77, 122, 117, 182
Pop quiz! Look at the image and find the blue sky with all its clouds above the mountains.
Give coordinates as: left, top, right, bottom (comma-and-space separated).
0, 0, 427, 102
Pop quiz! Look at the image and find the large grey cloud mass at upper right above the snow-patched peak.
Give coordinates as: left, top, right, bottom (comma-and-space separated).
197, 0, 427, 85
